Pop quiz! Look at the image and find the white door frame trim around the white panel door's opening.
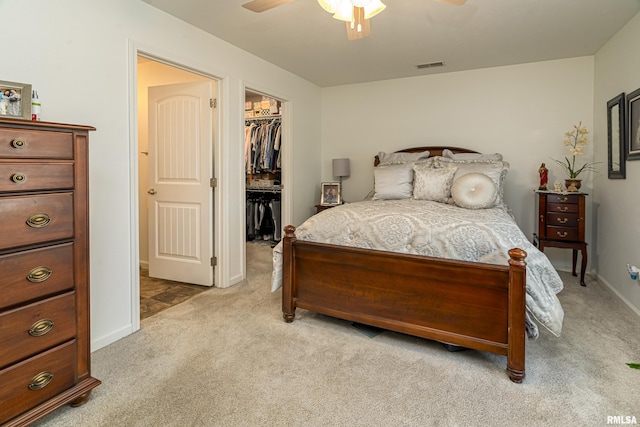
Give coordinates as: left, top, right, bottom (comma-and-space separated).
129, 40, 222, 333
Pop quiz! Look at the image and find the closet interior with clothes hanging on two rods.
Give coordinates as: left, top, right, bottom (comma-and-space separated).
244, 91, 282, 243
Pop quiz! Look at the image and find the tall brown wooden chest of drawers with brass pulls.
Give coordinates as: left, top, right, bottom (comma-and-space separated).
0, 119, 100, 426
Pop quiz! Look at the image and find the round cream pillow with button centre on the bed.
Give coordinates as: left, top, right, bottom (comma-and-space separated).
451, 172, 498, 209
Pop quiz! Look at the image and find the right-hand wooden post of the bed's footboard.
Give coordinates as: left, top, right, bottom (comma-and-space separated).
507, 248, 527, 383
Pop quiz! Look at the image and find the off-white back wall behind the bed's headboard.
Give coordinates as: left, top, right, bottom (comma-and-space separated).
317, 57, 606, 269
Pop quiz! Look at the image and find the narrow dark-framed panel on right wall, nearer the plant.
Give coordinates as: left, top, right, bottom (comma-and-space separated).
607, 93, 627, 179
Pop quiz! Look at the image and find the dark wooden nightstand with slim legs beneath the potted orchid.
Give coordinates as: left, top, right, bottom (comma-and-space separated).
533, 190, 587, 286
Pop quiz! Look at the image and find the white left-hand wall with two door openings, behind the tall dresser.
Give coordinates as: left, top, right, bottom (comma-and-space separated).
0, 0, 320, 350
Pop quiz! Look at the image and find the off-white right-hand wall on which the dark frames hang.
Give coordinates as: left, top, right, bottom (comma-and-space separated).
591, 14, 640, 314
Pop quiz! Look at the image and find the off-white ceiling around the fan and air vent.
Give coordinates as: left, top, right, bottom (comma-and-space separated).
144, 0, 640, 87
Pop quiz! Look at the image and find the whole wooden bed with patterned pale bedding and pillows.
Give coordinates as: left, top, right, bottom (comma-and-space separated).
272, 147, 563, 383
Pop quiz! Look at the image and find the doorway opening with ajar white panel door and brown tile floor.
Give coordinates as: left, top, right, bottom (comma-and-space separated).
137, 55, 216, 318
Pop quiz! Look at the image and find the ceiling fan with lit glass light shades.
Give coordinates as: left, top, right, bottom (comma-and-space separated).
242, 0, 467, 40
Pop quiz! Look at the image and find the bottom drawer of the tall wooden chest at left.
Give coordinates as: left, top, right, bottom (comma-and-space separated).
0, 340, 76, 423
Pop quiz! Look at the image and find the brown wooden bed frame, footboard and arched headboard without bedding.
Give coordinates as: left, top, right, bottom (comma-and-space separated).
282, 147, 527, 383
